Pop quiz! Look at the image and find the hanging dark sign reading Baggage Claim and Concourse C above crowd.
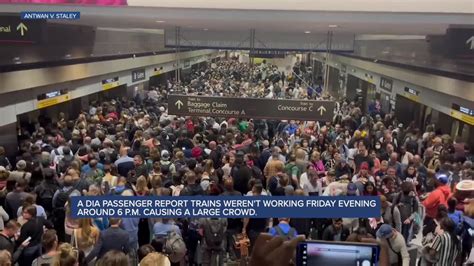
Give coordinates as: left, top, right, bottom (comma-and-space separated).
168, 95, 335, 121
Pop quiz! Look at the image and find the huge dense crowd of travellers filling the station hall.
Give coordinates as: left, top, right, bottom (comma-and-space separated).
0, 60, 474, 266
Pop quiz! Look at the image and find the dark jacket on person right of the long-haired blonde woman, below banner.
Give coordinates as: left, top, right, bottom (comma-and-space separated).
86, 227, 130, 262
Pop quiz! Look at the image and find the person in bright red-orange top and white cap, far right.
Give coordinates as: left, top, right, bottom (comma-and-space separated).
423, 173, 451, 222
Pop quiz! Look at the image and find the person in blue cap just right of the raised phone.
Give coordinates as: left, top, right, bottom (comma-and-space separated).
377, 224, 410, 266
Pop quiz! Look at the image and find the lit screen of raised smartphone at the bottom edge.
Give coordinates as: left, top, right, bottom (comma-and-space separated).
296, 241, 379, 266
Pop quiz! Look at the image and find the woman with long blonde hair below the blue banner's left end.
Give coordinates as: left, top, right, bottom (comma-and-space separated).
71, 218, 100, 256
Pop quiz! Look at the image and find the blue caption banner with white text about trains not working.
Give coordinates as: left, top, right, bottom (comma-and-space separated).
71, 196, 381, 219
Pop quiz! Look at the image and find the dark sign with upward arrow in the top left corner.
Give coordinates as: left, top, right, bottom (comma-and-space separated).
0, 16, 46, 44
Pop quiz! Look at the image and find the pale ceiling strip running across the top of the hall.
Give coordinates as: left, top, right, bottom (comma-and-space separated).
2, 5, 474, 35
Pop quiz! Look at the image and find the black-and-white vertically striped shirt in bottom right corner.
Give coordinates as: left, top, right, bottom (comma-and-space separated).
431, 232, 460, 266
